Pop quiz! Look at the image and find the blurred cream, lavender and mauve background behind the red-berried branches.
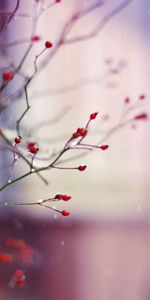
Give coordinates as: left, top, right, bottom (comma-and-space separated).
0, 0, 150, 300
